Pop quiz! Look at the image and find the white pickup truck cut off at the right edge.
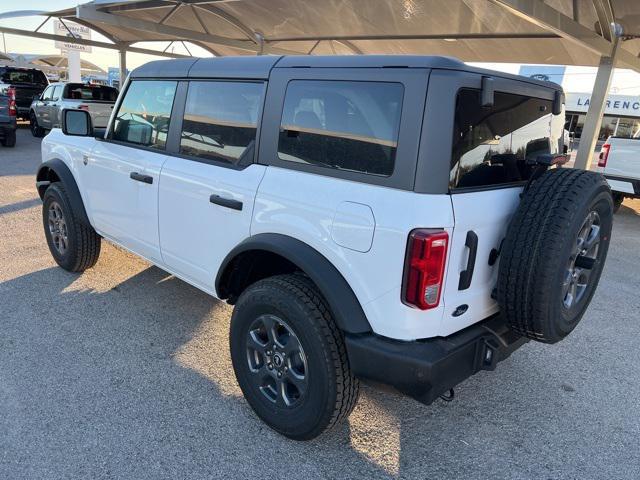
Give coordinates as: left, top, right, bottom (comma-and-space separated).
597, 134, 640, 211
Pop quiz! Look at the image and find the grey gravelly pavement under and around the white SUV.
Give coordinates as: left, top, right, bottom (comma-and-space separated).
0, 128, 640, 479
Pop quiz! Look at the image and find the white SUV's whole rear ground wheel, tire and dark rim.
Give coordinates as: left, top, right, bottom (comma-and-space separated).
230, 275, 359, 440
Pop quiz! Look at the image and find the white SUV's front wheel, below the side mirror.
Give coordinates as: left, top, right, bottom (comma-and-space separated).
42, 183, 101, 272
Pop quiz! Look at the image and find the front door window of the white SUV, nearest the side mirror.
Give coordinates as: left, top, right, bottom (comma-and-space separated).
111, 80, 177, 150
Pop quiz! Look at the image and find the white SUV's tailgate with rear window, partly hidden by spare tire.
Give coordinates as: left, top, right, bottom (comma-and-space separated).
427, 72, 564, 335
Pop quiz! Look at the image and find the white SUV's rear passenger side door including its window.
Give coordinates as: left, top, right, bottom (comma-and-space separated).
159, 80, 266, 293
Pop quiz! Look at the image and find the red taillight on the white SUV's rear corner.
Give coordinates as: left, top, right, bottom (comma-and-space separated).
402, 229, 449, 310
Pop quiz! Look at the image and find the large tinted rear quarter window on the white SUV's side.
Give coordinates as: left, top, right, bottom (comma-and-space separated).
278, 80, 404, 176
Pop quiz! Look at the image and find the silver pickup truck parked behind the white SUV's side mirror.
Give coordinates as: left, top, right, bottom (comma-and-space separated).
29, 83, 118, 137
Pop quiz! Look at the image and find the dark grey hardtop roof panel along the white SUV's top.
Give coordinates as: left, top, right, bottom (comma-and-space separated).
131, 55, 562, 90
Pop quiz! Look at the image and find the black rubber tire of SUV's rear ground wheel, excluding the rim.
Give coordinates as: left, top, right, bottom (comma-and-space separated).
229, 274, 359, 440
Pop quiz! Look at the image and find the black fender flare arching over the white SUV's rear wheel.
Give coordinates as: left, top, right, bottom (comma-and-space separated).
216, 233, 371, 334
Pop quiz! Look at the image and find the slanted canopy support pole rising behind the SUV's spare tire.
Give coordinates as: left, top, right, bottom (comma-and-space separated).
574, 39, 618, 170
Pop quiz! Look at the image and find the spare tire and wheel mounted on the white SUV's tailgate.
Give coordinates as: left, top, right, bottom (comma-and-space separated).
497, 168, 613, 343
